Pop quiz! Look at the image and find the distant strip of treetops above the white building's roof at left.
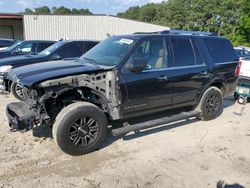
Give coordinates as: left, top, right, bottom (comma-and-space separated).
24, 6, 93, 15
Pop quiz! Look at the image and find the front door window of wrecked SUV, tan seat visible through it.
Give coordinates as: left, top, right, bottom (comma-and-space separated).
132, 39, 167, 69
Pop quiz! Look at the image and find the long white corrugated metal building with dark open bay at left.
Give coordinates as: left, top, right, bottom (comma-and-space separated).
0, 14, 169, 40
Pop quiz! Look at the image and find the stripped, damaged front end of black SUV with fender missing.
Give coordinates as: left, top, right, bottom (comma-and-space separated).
6, 70, 121, 130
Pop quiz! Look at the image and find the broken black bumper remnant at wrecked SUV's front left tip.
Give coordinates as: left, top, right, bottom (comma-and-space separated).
6, 102, 38, 130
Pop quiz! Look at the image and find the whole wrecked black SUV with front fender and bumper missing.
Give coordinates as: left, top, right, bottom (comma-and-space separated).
7, 30, 239, 155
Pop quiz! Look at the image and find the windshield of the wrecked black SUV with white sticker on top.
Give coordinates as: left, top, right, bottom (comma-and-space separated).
80, 36, 138, 66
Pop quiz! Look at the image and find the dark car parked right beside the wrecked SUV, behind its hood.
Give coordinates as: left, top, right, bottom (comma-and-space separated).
0, 40, 98, 99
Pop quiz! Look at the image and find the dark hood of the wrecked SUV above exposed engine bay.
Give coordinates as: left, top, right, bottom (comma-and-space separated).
7, 60, 110, 87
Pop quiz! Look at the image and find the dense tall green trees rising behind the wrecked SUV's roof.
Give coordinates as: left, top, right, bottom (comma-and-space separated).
117, 0, 250, 46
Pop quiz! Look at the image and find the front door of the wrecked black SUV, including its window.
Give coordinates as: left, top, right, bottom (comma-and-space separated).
119, 38, 172, 117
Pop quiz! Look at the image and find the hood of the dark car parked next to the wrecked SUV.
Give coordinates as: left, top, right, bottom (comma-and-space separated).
0, 55, 44, 67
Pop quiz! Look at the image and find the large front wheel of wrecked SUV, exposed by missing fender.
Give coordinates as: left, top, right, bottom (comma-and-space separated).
52, 102, 108, 156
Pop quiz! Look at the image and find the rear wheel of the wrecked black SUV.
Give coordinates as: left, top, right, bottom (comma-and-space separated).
196, 87, 223, 121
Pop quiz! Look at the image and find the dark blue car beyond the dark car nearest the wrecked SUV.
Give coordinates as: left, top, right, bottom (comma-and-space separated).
0, 40, 55, 59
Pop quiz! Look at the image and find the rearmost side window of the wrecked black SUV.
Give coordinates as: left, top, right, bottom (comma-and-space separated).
203, 38, 237, 64
